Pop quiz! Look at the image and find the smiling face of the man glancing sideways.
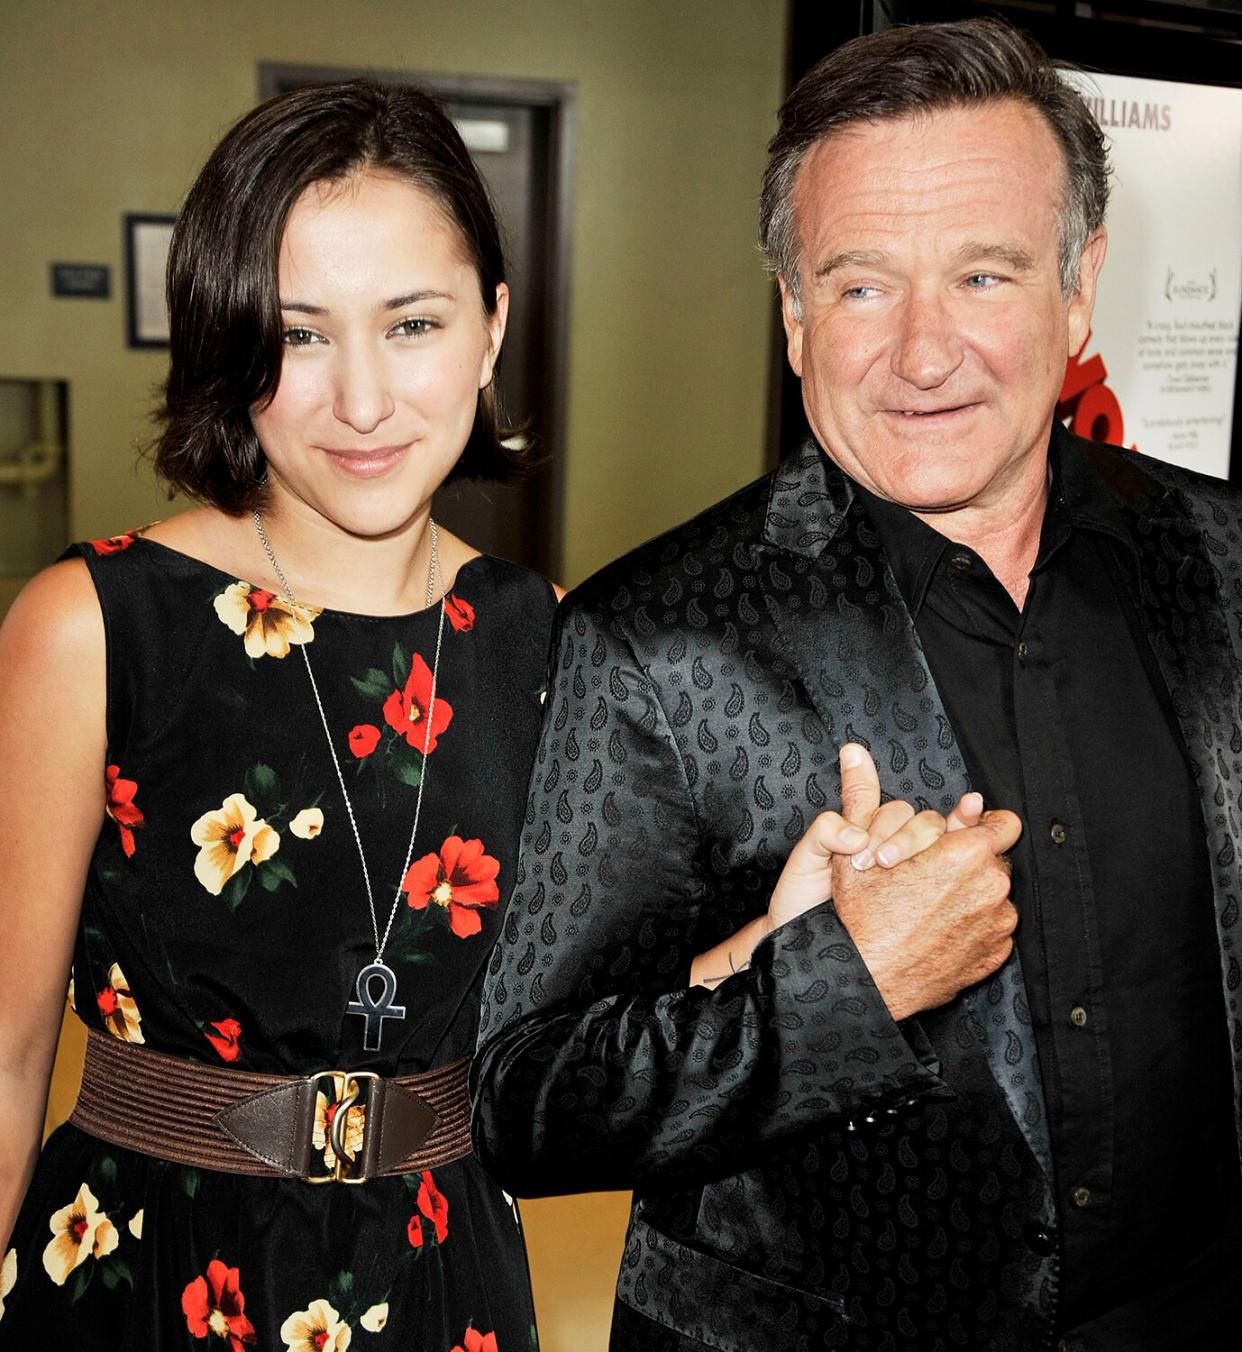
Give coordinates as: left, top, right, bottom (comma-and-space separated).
781, 101, 1104, 512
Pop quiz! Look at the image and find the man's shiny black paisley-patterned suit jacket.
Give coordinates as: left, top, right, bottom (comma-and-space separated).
472, 429, 1242, 1352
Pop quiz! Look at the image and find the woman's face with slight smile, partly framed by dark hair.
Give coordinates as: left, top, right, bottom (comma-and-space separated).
250, 173, 508, 537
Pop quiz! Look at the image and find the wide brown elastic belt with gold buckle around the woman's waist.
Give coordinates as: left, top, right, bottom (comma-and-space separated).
69, 1029, 470, 1183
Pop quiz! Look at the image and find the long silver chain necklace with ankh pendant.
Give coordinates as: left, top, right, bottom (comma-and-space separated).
254, 511, 445, 1052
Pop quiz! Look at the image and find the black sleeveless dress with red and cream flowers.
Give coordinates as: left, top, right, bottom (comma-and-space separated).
0, 534, 555, 1352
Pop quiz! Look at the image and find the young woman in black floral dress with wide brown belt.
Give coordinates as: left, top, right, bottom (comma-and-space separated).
0, 82, 555, 1352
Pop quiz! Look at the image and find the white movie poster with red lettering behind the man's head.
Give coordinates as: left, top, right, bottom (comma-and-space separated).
1058, 73, 1242, 479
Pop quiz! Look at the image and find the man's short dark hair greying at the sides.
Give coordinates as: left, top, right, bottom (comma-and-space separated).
760, 19, 1110, 304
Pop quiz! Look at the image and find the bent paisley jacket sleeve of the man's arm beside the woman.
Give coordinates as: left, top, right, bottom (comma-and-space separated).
470, 592, 947, 1197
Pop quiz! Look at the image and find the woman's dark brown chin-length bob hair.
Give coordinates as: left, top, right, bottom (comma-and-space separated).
154, 80, 526, 514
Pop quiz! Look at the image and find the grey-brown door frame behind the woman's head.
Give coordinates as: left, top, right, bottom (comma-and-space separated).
258, 61, 577, 577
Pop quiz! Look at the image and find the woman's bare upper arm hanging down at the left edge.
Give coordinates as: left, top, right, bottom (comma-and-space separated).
0, 560, 107, 1251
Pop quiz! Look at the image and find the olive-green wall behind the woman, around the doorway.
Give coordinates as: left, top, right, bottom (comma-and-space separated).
0, 0, 785, 592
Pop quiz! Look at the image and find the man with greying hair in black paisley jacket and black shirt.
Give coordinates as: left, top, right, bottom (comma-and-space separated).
473, 20, 1242, 1352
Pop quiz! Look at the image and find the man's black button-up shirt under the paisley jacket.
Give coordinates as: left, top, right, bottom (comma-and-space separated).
860, 441, 1242, 1348
